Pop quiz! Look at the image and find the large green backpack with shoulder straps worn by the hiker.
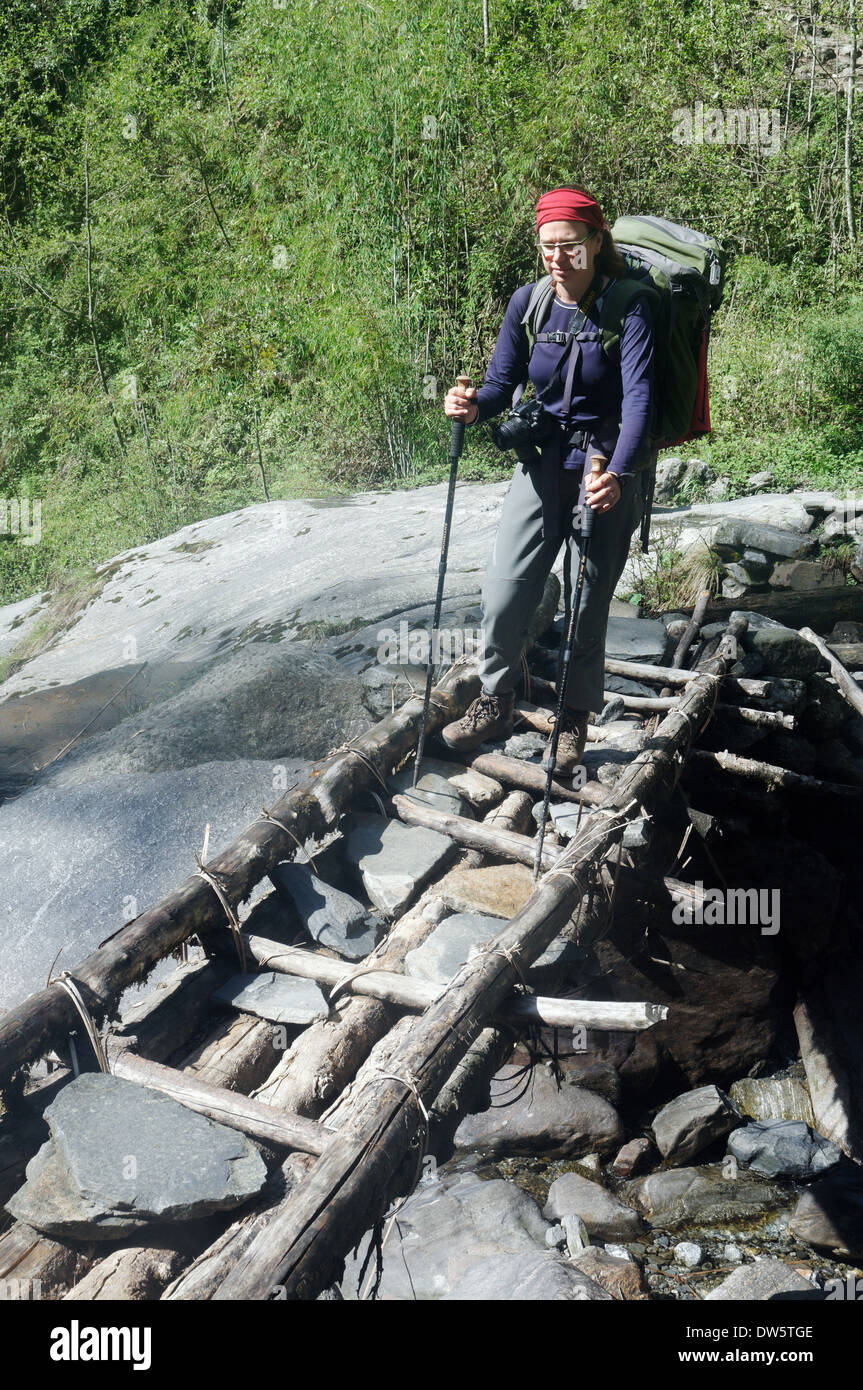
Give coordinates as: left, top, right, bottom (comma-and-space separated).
521, 217, 725, 552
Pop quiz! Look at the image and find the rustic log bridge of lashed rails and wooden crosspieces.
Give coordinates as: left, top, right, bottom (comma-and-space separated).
0, 591, 859, 1300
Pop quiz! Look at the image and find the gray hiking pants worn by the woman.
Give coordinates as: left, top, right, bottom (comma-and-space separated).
479, 463, 643, 713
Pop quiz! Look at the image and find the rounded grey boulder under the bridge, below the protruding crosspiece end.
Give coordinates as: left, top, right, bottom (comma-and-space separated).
454, 1065, 621, 1158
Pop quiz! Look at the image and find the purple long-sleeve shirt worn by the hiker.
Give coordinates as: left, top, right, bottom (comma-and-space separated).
477, 276, 653, 475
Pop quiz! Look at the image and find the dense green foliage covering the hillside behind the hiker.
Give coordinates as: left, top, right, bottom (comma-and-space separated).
0, 0, 863, 598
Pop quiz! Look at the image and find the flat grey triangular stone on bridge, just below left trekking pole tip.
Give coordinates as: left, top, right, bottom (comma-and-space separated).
345, 813, 459, 917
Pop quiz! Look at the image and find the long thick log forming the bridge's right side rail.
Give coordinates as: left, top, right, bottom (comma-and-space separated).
209, 636, 731, 1300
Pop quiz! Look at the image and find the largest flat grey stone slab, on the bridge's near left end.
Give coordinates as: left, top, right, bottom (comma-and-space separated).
7, 1073, 267, 1240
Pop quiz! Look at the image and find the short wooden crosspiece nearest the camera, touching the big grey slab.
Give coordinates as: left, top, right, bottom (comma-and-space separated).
110, 1048, 328, 1154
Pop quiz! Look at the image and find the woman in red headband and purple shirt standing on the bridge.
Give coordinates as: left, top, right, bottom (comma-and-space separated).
442, 188, 653, 776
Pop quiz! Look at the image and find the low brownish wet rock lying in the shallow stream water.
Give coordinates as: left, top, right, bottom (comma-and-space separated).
621, 1165, 787, 1229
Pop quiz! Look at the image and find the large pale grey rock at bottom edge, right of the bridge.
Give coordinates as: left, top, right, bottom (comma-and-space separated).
342, 1170, 610, 1301
